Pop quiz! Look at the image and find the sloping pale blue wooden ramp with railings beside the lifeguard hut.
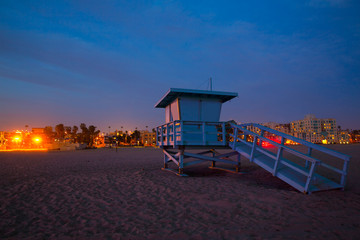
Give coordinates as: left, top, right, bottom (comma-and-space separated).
229, 124, 350, 193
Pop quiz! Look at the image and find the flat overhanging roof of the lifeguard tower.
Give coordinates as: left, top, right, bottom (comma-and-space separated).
155, 88, 238, 108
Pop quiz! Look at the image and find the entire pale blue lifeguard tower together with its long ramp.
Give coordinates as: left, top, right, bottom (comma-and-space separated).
155, 88, 351, 193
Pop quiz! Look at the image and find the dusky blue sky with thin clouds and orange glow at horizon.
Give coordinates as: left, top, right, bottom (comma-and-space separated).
0, 0, 360, 131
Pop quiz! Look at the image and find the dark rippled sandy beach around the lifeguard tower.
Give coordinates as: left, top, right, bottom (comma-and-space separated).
0, 145, 360, 239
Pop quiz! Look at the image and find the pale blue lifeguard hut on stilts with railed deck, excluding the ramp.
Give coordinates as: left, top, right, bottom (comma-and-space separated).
155, 88, 240, 176
